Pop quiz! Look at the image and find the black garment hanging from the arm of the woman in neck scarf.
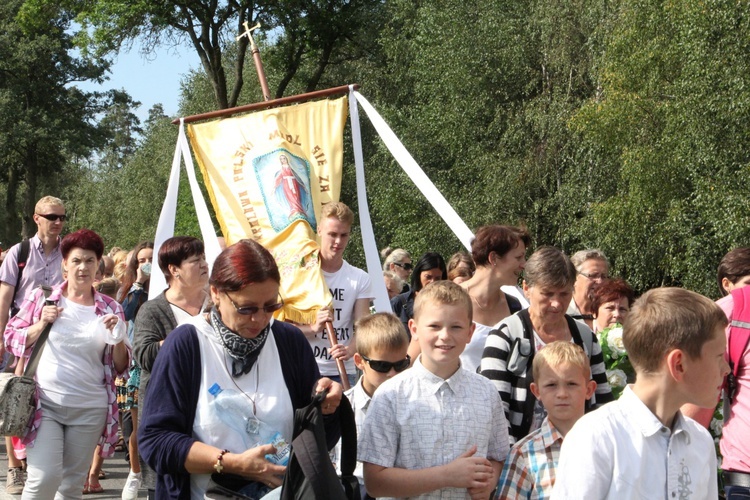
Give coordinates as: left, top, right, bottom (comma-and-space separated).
281, 393, 362, 500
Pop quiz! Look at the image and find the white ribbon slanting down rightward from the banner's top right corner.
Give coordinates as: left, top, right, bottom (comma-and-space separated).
351, 91, 474, 251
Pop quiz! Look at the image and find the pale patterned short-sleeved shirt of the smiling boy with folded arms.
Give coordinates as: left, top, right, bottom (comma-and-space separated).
357, 355, 510, 499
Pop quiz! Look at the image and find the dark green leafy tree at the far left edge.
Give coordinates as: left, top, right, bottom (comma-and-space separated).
0, 0, 107, 241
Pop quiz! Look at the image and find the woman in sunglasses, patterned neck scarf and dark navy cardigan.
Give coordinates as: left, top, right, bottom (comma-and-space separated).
138, 240, 342, 499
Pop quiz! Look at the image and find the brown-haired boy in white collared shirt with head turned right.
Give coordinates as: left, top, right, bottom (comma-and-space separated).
552, 288, 729, 500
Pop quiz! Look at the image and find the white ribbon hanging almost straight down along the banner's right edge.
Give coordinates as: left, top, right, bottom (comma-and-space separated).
349, 85, 393, 312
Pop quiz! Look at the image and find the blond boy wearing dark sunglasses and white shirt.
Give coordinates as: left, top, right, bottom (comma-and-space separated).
331, 313, 411, 499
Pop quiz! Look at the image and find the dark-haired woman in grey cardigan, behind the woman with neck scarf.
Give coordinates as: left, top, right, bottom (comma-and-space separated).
130, 236, 210, 498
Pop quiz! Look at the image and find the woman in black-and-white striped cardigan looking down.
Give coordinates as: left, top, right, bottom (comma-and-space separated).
480, 247, 614, 441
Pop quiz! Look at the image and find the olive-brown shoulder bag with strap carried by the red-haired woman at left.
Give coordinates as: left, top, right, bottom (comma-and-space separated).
0, 286, 54, 436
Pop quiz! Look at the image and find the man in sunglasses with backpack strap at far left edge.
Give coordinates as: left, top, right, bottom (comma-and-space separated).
0, 196, 66, 495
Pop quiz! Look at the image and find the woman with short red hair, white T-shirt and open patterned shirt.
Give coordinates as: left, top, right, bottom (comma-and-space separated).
5, 229, 130, 499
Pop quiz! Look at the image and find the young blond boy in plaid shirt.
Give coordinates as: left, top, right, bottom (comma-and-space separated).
495, 341, 596, 499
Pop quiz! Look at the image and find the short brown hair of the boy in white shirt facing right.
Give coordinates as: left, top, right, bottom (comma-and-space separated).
622, 288, 727, 373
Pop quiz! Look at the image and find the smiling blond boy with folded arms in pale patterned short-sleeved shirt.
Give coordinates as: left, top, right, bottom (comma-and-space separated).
357, 281, 509, 499
